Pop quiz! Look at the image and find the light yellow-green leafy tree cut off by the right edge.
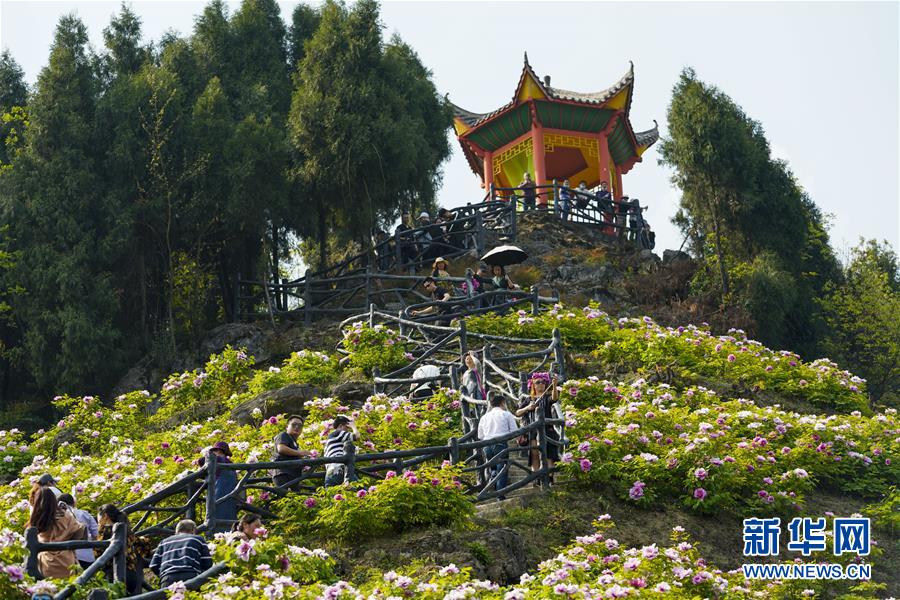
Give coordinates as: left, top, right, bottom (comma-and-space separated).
821, 240, 900, 406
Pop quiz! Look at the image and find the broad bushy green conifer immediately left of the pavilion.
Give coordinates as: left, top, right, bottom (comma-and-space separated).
289, 0, 450, 266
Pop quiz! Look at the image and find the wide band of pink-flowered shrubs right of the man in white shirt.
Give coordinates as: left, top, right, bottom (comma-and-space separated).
562, 378, 900, 514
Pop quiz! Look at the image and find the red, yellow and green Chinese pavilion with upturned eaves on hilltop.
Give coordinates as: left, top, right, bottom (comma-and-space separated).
453, 54, 659, 199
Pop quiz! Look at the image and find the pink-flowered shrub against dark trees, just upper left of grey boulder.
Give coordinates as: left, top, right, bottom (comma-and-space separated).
154, 346, 254, 422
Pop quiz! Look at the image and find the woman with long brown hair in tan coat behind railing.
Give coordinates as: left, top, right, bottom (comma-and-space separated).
28, 487, 87, 579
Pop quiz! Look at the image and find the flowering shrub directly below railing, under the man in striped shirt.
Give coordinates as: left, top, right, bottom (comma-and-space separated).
275, 462, 473, 542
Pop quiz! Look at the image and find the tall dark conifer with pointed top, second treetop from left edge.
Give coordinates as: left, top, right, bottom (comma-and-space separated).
3, 16, 121, 392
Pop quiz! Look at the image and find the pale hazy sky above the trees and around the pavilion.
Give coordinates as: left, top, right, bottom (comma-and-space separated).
0, 0, 900, 259
